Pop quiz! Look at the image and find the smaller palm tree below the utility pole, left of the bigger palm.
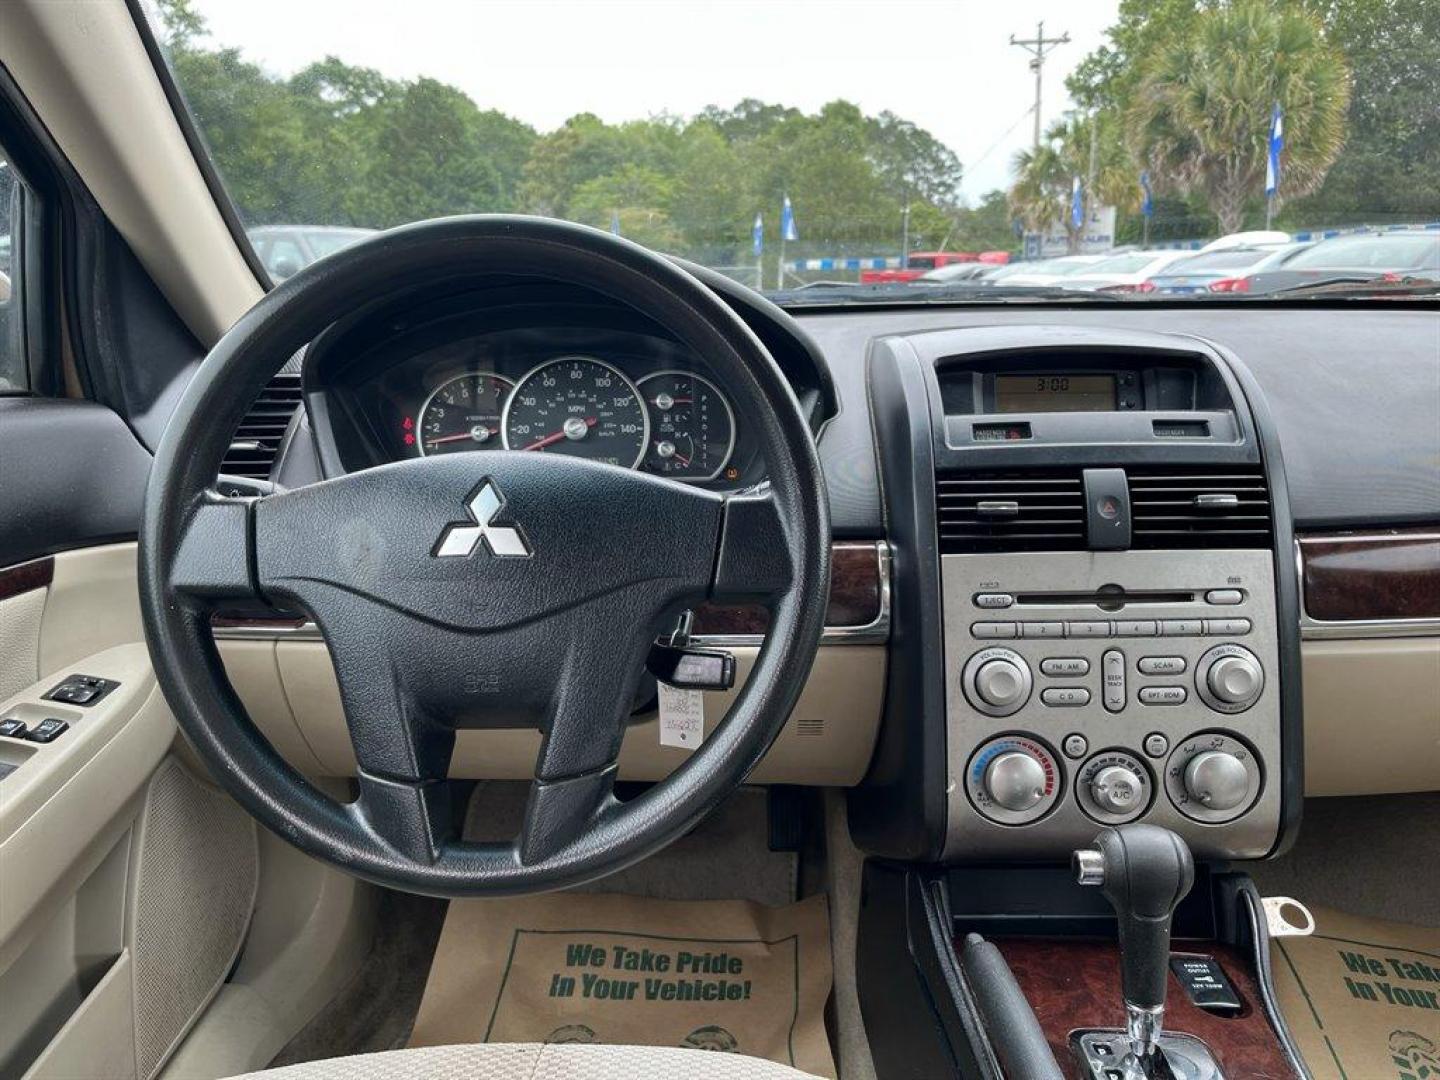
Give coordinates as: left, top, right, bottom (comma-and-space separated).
1009, 112, 1139, 252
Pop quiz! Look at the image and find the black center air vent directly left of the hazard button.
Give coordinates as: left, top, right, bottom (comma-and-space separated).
935, 469, 1086, 554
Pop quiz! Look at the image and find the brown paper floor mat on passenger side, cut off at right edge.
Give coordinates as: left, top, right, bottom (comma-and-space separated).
1270, 910, 1440, 1080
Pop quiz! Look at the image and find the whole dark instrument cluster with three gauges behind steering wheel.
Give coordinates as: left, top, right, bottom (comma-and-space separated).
354, 327, 760, 487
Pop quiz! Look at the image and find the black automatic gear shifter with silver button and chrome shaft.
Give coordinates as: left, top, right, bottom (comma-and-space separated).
1074, 825, 1195, 1076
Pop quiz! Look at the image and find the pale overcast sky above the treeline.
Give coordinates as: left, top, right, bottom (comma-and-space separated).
185, 0, 1119, 204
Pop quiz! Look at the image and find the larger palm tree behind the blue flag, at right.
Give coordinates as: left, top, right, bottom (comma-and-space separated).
1126, 0, 1351, 233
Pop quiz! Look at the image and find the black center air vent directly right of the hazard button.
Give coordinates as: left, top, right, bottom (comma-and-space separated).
1126, 465, 1272, 547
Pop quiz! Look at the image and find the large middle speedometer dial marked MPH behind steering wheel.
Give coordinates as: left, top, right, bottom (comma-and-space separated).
500, 356, 649, 469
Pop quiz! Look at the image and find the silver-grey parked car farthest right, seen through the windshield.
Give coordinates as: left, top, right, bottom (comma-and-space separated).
1231, 229, 1440, 292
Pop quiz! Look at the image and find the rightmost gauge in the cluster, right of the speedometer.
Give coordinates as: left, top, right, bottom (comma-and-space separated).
636, 372, 734, 480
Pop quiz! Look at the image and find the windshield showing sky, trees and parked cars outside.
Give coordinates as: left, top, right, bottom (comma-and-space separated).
143, 0, 1440, 304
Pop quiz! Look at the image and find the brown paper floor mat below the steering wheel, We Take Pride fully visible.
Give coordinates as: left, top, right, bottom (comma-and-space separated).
410, 893, 835, 1077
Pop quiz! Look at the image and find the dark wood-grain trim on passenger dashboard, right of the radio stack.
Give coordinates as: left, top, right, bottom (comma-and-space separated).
1297, 526, 1440, 632
